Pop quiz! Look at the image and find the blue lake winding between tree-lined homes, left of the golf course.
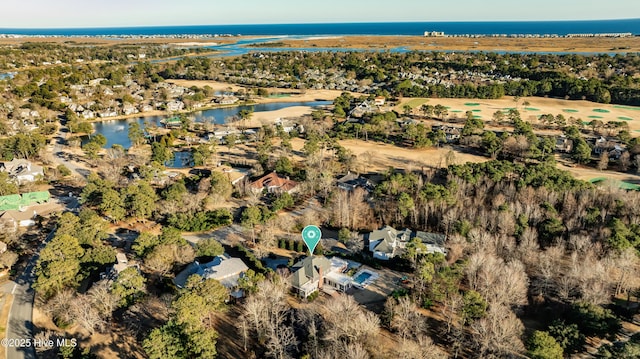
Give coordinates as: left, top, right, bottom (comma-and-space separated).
93, 101, 332, 148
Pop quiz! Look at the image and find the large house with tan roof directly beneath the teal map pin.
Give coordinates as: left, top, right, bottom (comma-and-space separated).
291, 256, 353, 298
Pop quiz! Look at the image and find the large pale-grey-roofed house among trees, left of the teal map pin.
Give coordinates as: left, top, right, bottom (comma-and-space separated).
174, 254, 249, 298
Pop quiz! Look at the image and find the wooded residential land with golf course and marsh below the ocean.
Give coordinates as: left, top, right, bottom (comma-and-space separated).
0, 18, 640, 359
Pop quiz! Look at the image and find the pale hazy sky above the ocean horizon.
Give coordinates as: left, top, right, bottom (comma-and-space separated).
5, 0, 640, 28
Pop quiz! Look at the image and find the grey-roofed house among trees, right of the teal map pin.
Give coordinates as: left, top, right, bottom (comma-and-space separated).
368, 226, 447, 260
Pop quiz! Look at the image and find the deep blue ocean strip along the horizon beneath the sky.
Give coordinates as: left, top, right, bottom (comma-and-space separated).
0, 19, 640, 36
